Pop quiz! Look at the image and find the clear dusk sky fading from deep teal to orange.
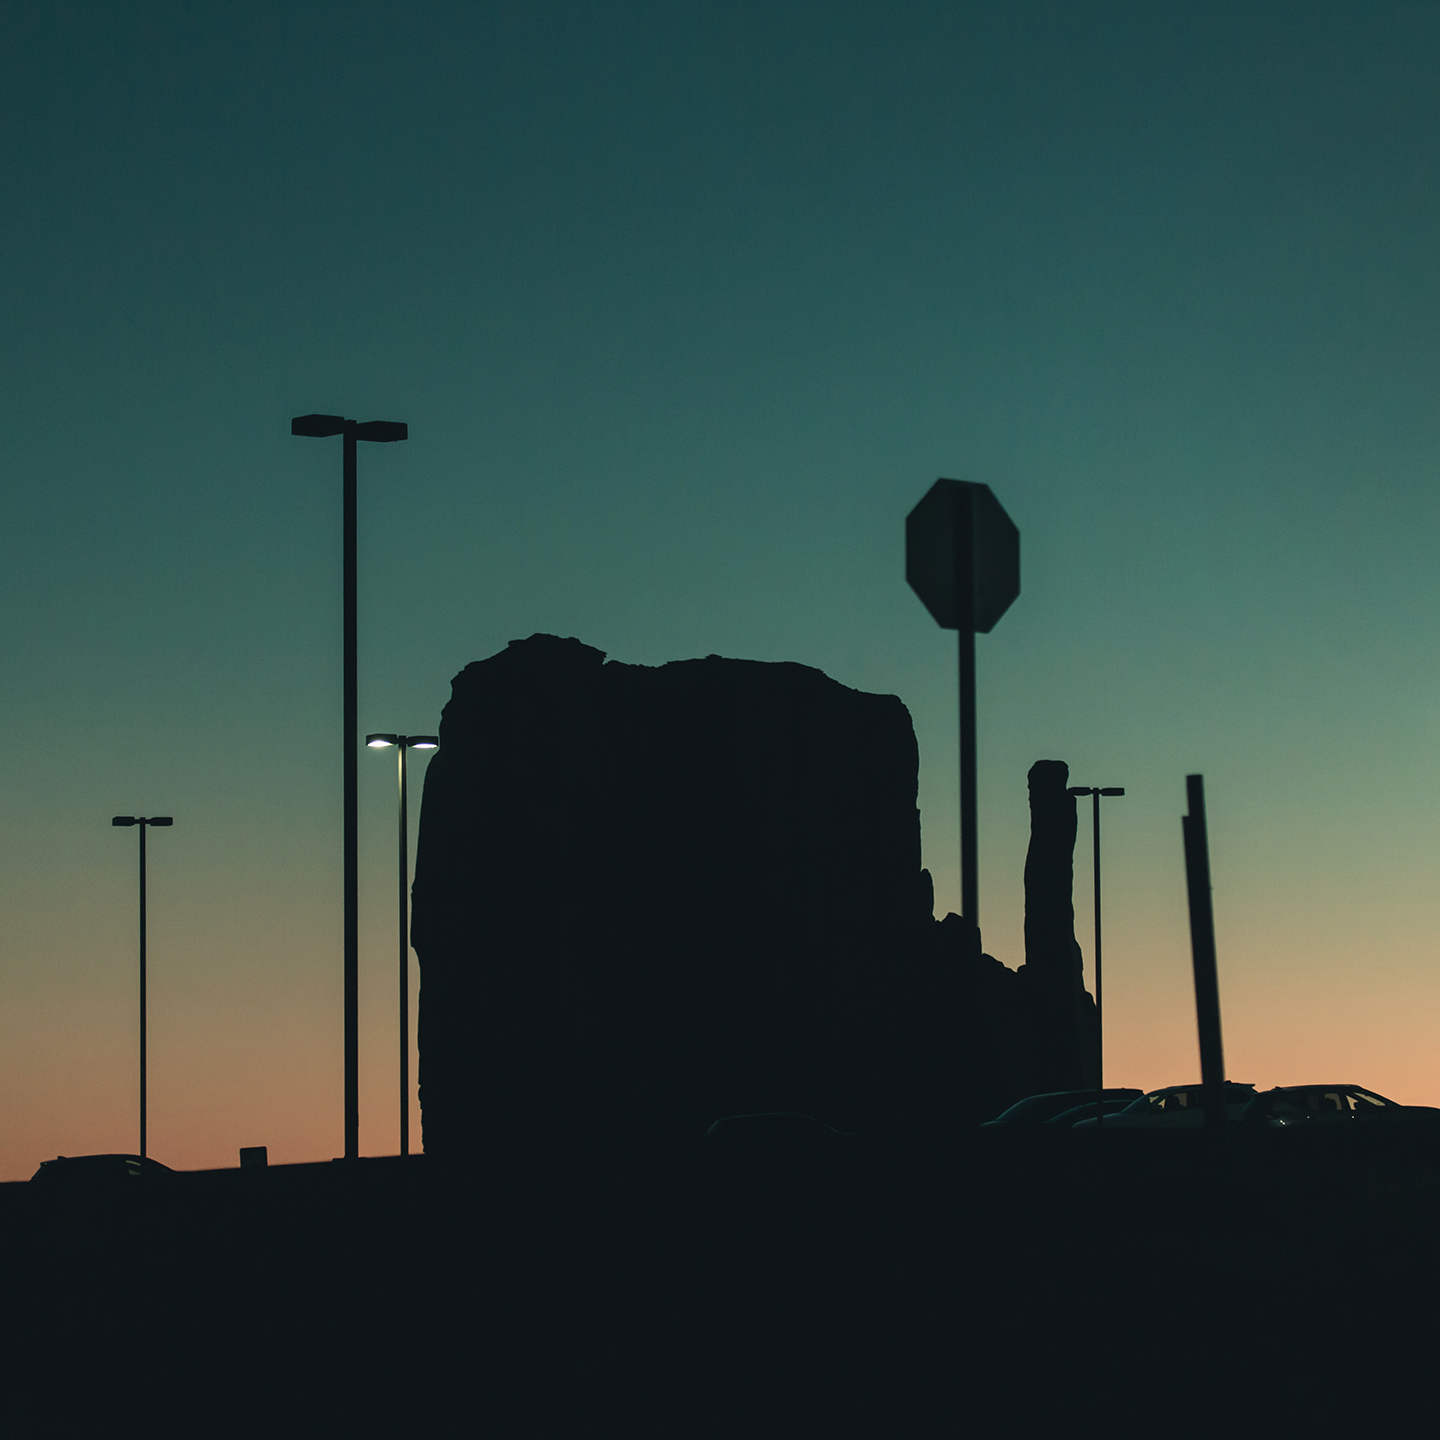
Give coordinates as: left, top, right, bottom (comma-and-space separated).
0, 0, 1440, 1179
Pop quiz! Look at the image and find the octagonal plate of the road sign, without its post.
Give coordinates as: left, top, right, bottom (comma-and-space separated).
904, 480, 1020, 634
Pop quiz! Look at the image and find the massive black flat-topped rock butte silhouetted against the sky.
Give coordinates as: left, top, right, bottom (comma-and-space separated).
412, 635, 1100, 1158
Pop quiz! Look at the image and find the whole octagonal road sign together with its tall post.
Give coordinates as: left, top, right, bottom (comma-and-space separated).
904, 480, 1020, 936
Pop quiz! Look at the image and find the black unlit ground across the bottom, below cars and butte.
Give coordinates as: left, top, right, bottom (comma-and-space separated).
0, 1135, 1440, 1437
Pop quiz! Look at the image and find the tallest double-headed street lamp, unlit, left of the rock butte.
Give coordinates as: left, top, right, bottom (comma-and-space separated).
289, 415, 410, 1161
